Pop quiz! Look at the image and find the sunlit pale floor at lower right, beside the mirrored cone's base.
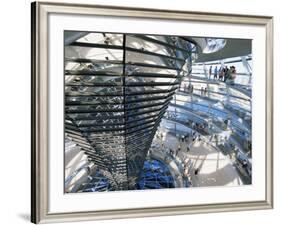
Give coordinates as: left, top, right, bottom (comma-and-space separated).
152, 134, 243, 187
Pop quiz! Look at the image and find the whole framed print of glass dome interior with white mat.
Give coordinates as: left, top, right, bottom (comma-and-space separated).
31, 2, 273, 223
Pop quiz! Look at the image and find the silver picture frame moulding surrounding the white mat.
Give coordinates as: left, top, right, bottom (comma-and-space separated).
31, 2, 273, 223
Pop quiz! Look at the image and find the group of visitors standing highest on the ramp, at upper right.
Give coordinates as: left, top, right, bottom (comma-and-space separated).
209, 66, 236, 82
